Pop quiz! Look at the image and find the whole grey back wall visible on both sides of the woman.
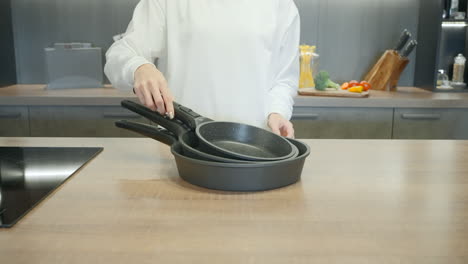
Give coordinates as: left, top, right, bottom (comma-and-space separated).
13, 0, 419, 85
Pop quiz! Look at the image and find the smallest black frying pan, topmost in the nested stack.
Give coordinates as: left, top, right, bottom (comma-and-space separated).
122, 101, 295, 161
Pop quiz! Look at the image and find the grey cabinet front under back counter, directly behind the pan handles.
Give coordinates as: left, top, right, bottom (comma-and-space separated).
30, 106, 149, 137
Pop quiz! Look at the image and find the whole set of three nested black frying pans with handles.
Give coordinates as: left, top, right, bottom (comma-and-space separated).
116, 100, 310, 191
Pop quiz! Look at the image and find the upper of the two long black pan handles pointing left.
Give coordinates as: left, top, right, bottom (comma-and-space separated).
121, 100, 188, 137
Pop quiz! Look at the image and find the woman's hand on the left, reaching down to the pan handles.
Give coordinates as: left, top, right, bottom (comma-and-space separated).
133, 64, 174, 119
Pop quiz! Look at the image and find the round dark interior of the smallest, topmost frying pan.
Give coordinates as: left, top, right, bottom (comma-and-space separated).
198, 122, 292, 158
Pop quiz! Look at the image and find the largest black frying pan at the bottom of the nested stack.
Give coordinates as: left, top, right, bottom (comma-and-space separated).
116, 120, 310, 192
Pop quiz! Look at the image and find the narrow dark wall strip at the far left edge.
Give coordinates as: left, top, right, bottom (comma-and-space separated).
0, 0, 16, 87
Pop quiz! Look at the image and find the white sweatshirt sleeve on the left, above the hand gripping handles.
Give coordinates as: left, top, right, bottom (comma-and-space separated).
104, 0, 166, 90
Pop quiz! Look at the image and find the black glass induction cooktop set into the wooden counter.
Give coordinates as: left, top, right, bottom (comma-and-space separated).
0, 147, 103, 227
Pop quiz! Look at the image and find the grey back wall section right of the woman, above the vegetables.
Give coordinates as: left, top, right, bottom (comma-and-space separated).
296, 0, 419, 85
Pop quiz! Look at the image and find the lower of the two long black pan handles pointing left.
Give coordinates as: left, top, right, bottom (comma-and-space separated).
115, 120, 177, 146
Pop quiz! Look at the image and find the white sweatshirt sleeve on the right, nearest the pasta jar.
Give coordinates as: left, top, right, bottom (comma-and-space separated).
268, 1, 300, 120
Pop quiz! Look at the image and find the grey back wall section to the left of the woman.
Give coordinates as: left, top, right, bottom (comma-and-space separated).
12, 0, 138, 83
